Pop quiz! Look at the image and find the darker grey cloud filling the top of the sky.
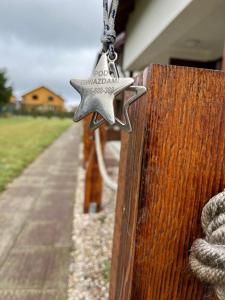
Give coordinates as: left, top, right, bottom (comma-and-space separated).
0, 0, 102, 48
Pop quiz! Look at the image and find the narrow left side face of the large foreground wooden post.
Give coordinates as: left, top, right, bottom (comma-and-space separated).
109, 70, 148, 300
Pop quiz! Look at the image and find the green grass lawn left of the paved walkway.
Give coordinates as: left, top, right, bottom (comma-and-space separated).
0, 117, 72, 191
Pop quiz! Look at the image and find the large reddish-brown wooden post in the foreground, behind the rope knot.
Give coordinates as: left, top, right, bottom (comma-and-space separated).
110, 65, 225, 300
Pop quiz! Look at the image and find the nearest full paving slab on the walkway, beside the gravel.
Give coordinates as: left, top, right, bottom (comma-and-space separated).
0, 247, 69, 290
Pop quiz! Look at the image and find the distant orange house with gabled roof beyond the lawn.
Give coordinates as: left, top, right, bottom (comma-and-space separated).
22, 86, 64, 112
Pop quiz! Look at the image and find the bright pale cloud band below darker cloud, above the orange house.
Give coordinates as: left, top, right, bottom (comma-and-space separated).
0, 38, 97, 101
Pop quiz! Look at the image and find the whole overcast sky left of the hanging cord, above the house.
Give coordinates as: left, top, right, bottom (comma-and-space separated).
0, 0, 103, 108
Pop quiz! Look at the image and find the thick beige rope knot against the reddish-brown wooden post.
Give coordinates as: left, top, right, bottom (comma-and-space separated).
189, 191, 225, 300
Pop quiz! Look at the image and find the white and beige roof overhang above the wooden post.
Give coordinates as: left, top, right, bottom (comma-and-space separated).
117, 0, 225, 70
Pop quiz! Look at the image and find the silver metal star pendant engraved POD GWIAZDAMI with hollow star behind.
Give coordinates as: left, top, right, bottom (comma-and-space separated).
70, 53, 146, 132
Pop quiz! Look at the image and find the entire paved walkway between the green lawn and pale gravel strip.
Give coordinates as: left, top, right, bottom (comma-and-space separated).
0, 125, 80, 300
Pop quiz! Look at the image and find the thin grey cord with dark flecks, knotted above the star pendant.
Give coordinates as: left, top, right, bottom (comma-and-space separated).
102, 0, 119, 57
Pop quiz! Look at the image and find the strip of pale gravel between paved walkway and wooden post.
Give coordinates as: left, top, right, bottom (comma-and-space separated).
68, 143, 119, 300
